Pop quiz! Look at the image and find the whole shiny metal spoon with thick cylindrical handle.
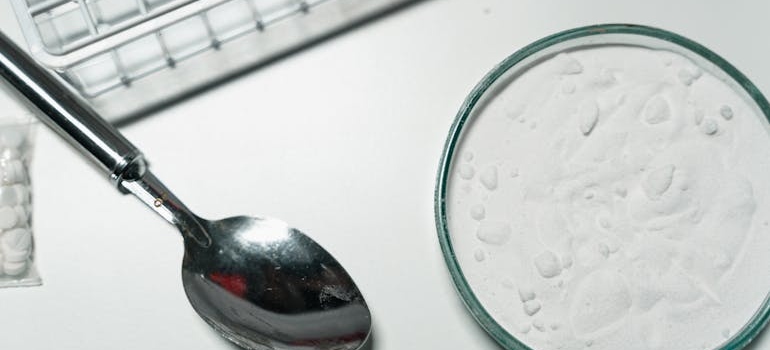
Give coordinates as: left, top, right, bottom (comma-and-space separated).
0, 33, 371, 350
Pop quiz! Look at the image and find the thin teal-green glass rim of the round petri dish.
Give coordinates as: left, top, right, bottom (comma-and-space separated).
434, 24, 770, 350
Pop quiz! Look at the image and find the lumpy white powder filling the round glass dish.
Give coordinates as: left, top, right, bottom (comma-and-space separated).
447, 46, 770, 350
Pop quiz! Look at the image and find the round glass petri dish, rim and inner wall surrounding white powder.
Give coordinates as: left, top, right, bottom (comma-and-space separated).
434, 24, 770, 350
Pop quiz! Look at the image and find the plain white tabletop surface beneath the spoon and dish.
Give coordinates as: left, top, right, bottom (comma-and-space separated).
0, 0, 770, 350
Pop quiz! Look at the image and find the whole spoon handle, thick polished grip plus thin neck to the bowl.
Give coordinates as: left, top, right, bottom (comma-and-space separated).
0, 32, 211, 247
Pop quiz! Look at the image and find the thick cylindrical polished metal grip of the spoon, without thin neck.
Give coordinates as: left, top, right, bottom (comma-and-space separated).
0, 32, 147, 191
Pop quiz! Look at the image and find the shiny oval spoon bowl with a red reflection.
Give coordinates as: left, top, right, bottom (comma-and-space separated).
182, 216, 371, 350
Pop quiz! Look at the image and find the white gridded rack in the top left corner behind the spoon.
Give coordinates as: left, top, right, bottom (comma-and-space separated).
11, 0, 416, 120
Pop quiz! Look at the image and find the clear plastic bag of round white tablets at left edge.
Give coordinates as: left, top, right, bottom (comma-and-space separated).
0, 84, 42, 287
